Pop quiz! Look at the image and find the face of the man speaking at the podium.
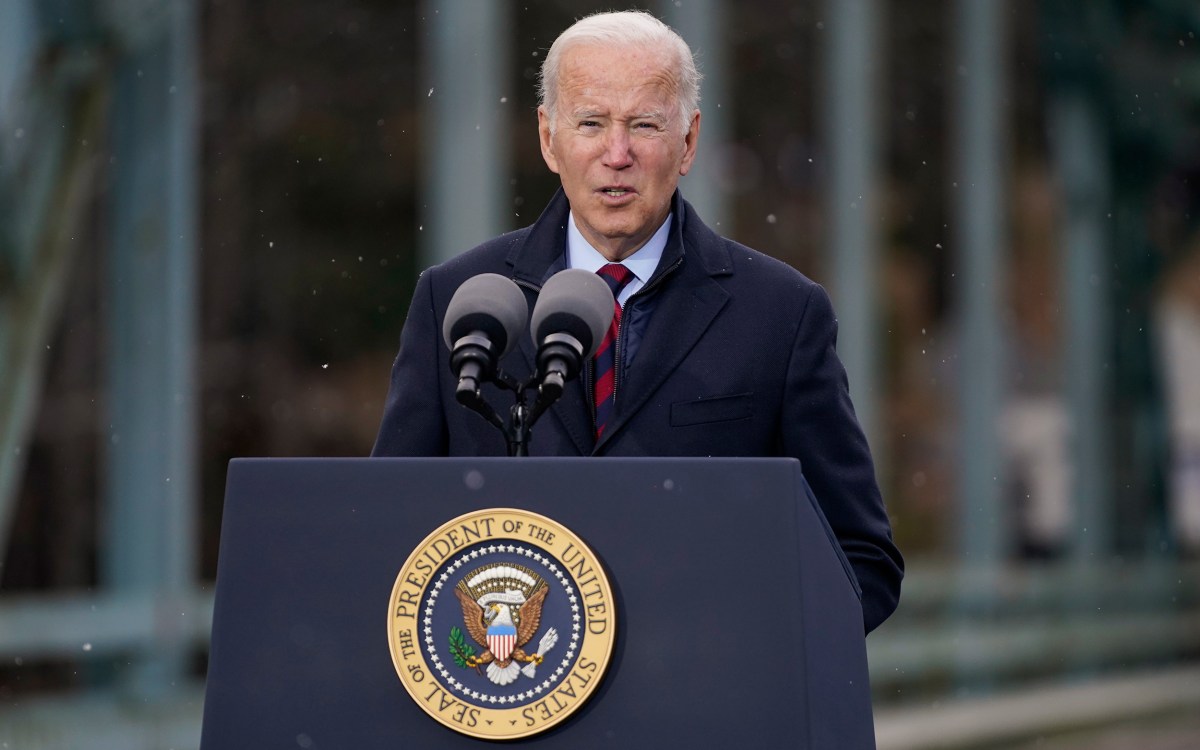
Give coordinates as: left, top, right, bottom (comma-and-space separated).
538, 44, 700, 260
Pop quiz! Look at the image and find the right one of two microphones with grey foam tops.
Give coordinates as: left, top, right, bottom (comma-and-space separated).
529, 269, 614, 401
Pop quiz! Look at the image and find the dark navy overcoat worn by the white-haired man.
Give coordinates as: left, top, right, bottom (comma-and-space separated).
372, 191, 904, 631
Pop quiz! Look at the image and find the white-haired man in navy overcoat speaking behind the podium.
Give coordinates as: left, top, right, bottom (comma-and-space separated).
372, 12, 904, 631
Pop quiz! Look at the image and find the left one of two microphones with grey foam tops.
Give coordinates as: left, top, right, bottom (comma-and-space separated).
442, 274, 528, 404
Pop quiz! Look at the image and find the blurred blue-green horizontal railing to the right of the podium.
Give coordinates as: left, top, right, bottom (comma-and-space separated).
868, 559, 1200, 722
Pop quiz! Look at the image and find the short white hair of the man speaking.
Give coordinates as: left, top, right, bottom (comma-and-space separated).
538, 11, 701, 132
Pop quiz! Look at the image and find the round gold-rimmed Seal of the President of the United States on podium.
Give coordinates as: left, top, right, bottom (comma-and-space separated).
388, 509, 617, 739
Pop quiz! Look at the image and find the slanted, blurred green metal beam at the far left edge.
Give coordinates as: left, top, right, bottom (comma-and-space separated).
0, 48, 108, 564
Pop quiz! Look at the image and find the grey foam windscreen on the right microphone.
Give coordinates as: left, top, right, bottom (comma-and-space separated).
529, 269, 613, 358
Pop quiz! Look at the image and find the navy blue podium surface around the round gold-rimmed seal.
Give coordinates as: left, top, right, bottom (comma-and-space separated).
202, 458, 875, 750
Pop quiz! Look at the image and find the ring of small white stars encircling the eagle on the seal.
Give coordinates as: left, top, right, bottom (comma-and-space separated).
424, 545, 581, 706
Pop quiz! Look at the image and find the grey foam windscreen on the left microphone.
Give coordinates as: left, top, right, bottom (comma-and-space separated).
442, 274, 529, 356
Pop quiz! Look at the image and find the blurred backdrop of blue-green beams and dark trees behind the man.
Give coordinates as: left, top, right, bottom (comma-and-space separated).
0, 0, 1200, 750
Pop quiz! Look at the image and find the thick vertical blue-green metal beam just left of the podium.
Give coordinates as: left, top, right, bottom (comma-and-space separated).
101, 0, 199, 696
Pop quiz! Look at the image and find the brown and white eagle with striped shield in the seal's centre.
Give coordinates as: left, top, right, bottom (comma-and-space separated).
450, 564, 558, 685
